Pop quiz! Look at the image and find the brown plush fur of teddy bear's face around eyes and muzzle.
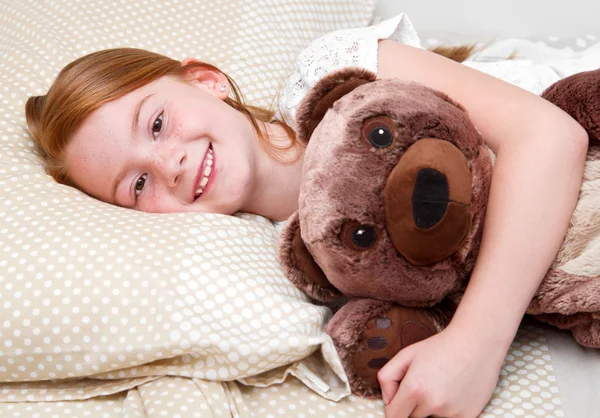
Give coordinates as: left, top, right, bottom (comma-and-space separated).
283, 75, 491, 306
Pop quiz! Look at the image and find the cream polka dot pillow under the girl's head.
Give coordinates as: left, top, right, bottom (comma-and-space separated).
0, 0, 374, 393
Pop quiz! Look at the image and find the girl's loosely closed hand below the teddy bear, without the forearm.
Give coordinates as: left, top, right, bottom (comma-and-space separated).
377, 325, 506, 418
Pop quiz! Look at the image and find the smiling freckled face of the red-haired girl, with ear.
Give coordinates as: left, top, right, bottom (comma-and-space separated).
66, 71, 259, 214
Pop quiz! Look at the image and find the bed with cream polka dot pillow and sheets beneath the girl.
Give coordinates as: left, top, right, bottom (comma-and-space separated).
0, 0, 600, 418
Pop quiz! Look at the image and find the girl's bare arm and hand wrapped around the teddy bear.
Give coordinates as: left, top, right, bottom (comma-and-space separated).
378, 40, 587, 417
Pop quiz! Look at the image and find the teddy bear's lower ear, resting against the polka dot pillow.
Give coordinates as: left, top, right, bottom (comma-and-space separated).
279, 211, 341, 302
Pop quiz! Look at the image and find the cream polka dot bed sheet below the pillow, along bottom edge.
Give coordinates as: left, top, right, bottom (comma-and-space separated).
0, 323, 564, 418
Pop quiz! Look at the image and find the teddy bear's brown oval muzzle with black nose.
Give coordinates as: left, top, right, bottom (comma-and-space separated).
384, 138, 472, 265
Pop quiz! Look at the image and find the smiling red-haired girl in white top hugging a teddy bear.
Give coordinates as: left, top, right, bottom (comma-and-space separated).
26, 15, 587, 417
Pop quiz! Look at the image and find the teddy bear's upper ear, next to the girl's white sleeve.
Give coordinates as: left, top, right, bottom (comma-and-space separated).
296, 67, 377, 144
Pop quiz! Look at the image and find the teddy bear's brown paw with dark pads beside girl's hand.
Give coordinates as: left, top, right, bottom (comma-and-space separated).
327, 299, 453, 398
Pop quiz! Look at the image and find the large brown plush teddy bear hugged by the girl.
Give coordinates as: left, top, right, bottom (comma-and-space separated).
279, 68, 600, 398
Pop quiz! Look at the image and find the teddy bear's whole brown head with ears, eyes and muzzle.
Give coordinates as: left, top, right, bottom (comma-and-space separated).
280, 68, 492, 306
